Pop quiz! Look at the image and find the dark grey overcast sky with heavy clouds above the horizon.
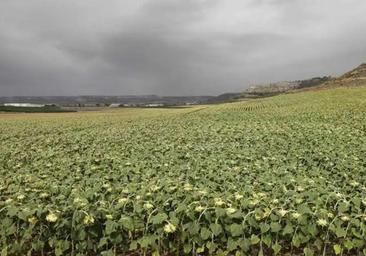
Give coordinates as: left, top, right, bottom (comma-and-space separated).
0, 0, 366, 96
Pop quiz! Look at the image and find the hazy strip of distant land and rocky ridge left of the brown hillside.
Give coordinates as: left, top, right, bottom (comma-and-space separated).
0, 76, 332, 112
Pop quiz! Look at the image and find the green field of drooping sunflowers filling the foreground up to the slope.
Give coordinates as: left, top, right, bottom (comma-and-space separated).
0, 87, 366, 255
